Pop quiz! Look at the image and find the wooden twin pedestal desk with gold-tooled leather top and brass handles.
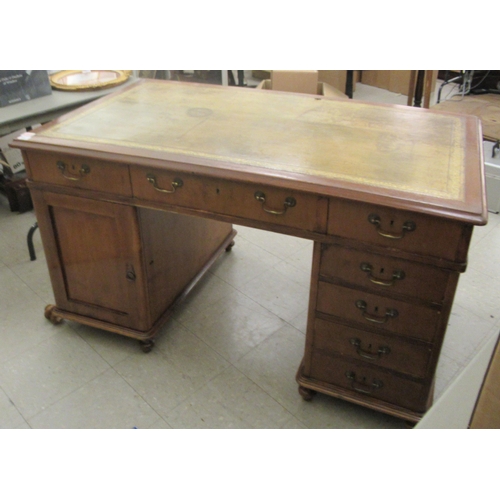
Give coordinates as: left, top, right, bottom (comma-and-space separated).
13, 80, 487, 421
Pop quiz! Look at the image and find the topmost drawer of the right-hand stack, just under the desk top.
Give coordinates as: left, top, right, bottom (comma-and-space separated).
328, 198, 472, 262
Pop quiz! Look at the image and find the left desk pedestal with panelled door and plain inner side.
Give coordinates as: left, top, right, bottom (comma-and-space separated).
33, 189, 236, 351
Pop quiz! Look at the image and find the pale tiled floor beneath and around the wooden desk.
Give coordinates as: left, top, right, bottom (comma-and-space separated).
0, 76, 500, 429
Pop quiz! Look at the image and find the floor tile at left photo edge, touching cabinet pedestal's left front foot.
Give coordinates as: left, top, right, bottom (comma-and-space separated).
0, 325, 109, 419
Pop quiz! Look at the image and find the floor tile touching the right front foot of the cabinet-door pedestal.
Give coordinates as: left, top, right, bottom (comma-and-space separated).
114, 322, 229, 417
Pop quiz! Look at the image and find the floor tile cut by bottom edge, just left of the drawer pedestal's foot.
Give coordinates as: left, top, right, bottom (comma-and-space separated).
165, 366, 304, 429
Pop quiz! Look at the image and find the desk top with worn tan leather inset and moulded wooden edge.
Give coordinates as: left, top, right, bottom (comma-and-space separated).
14, 80, 486, 224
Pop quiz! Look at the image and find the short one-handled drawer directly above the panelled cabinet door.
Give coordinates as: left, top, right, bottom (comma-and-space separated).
27, 151, 132, 196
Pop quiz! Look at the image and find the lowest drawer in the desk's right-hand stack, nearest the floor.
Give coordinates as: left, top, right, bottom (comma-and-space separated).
305, 350, 427, 413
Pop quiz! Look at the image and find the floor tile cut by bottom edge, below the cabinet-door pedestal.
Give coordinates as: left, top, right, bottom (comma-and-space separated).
28, 368, 158, 429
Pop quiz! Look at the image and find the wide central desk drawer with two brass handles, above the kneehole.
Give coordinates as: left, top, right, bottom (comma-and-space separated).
131, 167, 328, 234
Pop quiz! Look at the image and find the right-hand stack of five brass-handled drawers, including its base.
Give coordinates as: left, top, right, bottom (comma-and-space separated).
297, 199, 471, 421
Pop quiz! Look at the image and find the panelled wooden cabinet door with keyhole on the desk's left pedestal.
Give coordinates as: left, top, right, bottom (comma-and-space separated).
34, 192, 150, 331
